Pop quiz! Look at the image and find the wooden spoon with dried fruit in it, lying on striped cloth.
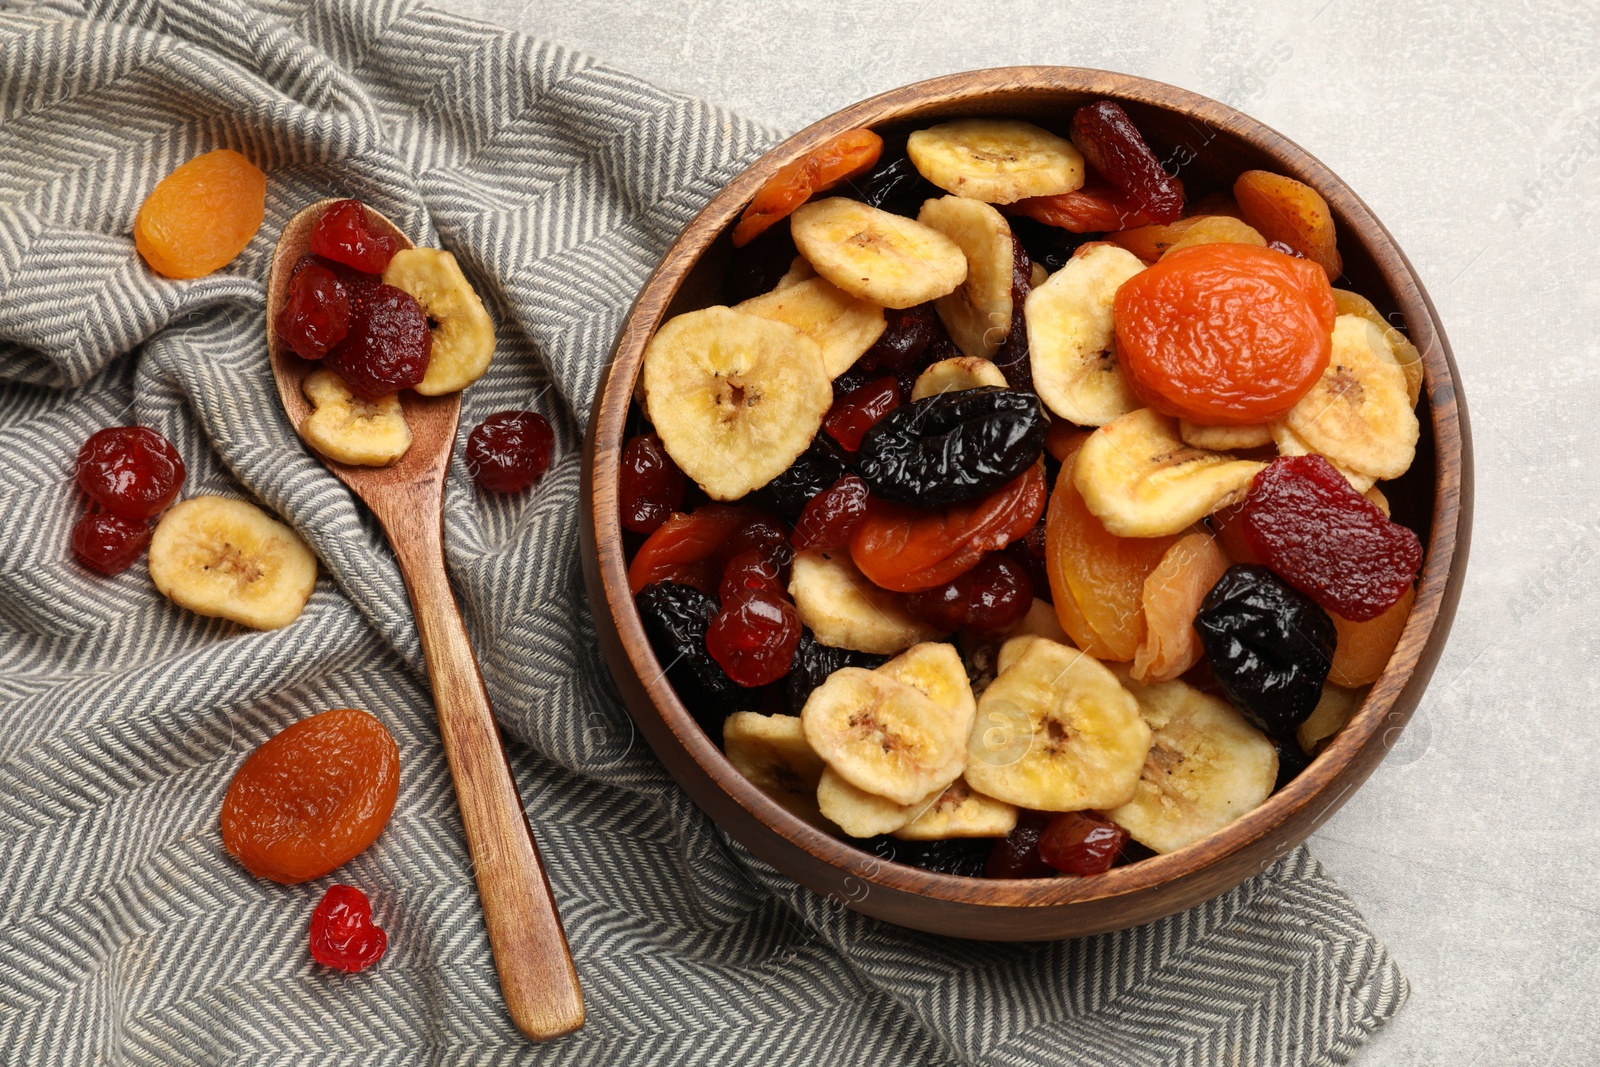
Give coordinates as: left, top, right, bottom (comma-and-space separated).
267, 200, 584, 1041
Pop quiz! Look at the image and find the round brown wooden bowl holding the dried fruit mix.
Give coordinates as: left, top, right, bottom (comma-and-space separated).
582, 67, 1472, 941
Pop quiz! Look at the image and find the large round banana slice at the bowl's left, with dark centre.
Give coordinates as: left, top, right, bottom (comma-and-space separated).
642, 307, 834, 501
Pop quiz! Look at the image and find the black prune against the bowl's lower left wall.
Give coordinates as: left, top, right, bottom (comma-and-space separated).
634, 582, 741, 744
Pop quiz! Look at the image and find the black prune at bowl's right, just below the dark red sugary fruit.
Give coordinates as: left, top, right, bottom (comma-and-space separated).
1194, 563, 1338, 739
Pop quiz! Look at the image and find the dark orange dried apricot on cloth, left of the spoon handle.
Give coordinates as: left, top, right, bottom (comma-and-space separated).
222, 707, 400, 885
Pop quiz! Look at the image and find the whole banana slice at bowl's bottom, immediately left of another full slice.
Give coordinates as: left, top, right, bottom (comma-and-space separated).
800, 667, 966, 805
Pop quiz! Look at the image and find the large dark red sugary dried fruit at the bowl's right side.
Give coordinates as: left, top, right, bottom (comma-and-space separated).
1240, 454, 1422, 622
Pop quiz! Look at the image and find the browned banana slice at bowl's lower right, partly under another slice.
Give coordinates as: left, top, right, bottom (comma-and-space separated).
1106, 669, 1278, 853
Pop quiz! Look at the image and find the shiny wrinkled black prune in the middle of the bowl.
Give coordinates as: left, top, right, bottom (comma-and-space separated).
856, 386, 1045, 507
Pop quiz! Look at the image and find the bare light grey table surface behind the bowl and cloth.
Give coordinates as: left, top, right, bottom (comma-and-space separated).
434, 0, 1600, 1067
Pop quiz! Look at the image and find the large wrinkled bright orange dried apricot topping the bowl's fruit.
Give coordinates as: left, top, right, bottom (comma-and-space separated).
1114, 245, 1334, 426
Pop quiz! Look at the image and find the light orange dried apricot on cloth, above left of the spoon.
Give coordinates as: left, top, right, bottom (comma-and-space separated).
133, 149, 267, 278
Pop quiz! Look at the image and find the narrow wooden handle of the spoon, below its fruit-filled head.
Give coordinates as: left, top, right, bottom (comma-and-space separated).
390, 510, 584, 1041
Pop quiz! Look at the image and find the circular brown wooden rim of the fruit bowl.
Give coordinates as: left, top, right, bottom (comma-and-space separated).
584, 66, 1472, 910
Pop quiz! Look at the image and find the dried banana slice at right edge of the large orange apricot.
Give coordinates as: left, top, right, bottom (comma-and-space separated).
1283, 315, 1421, 478
